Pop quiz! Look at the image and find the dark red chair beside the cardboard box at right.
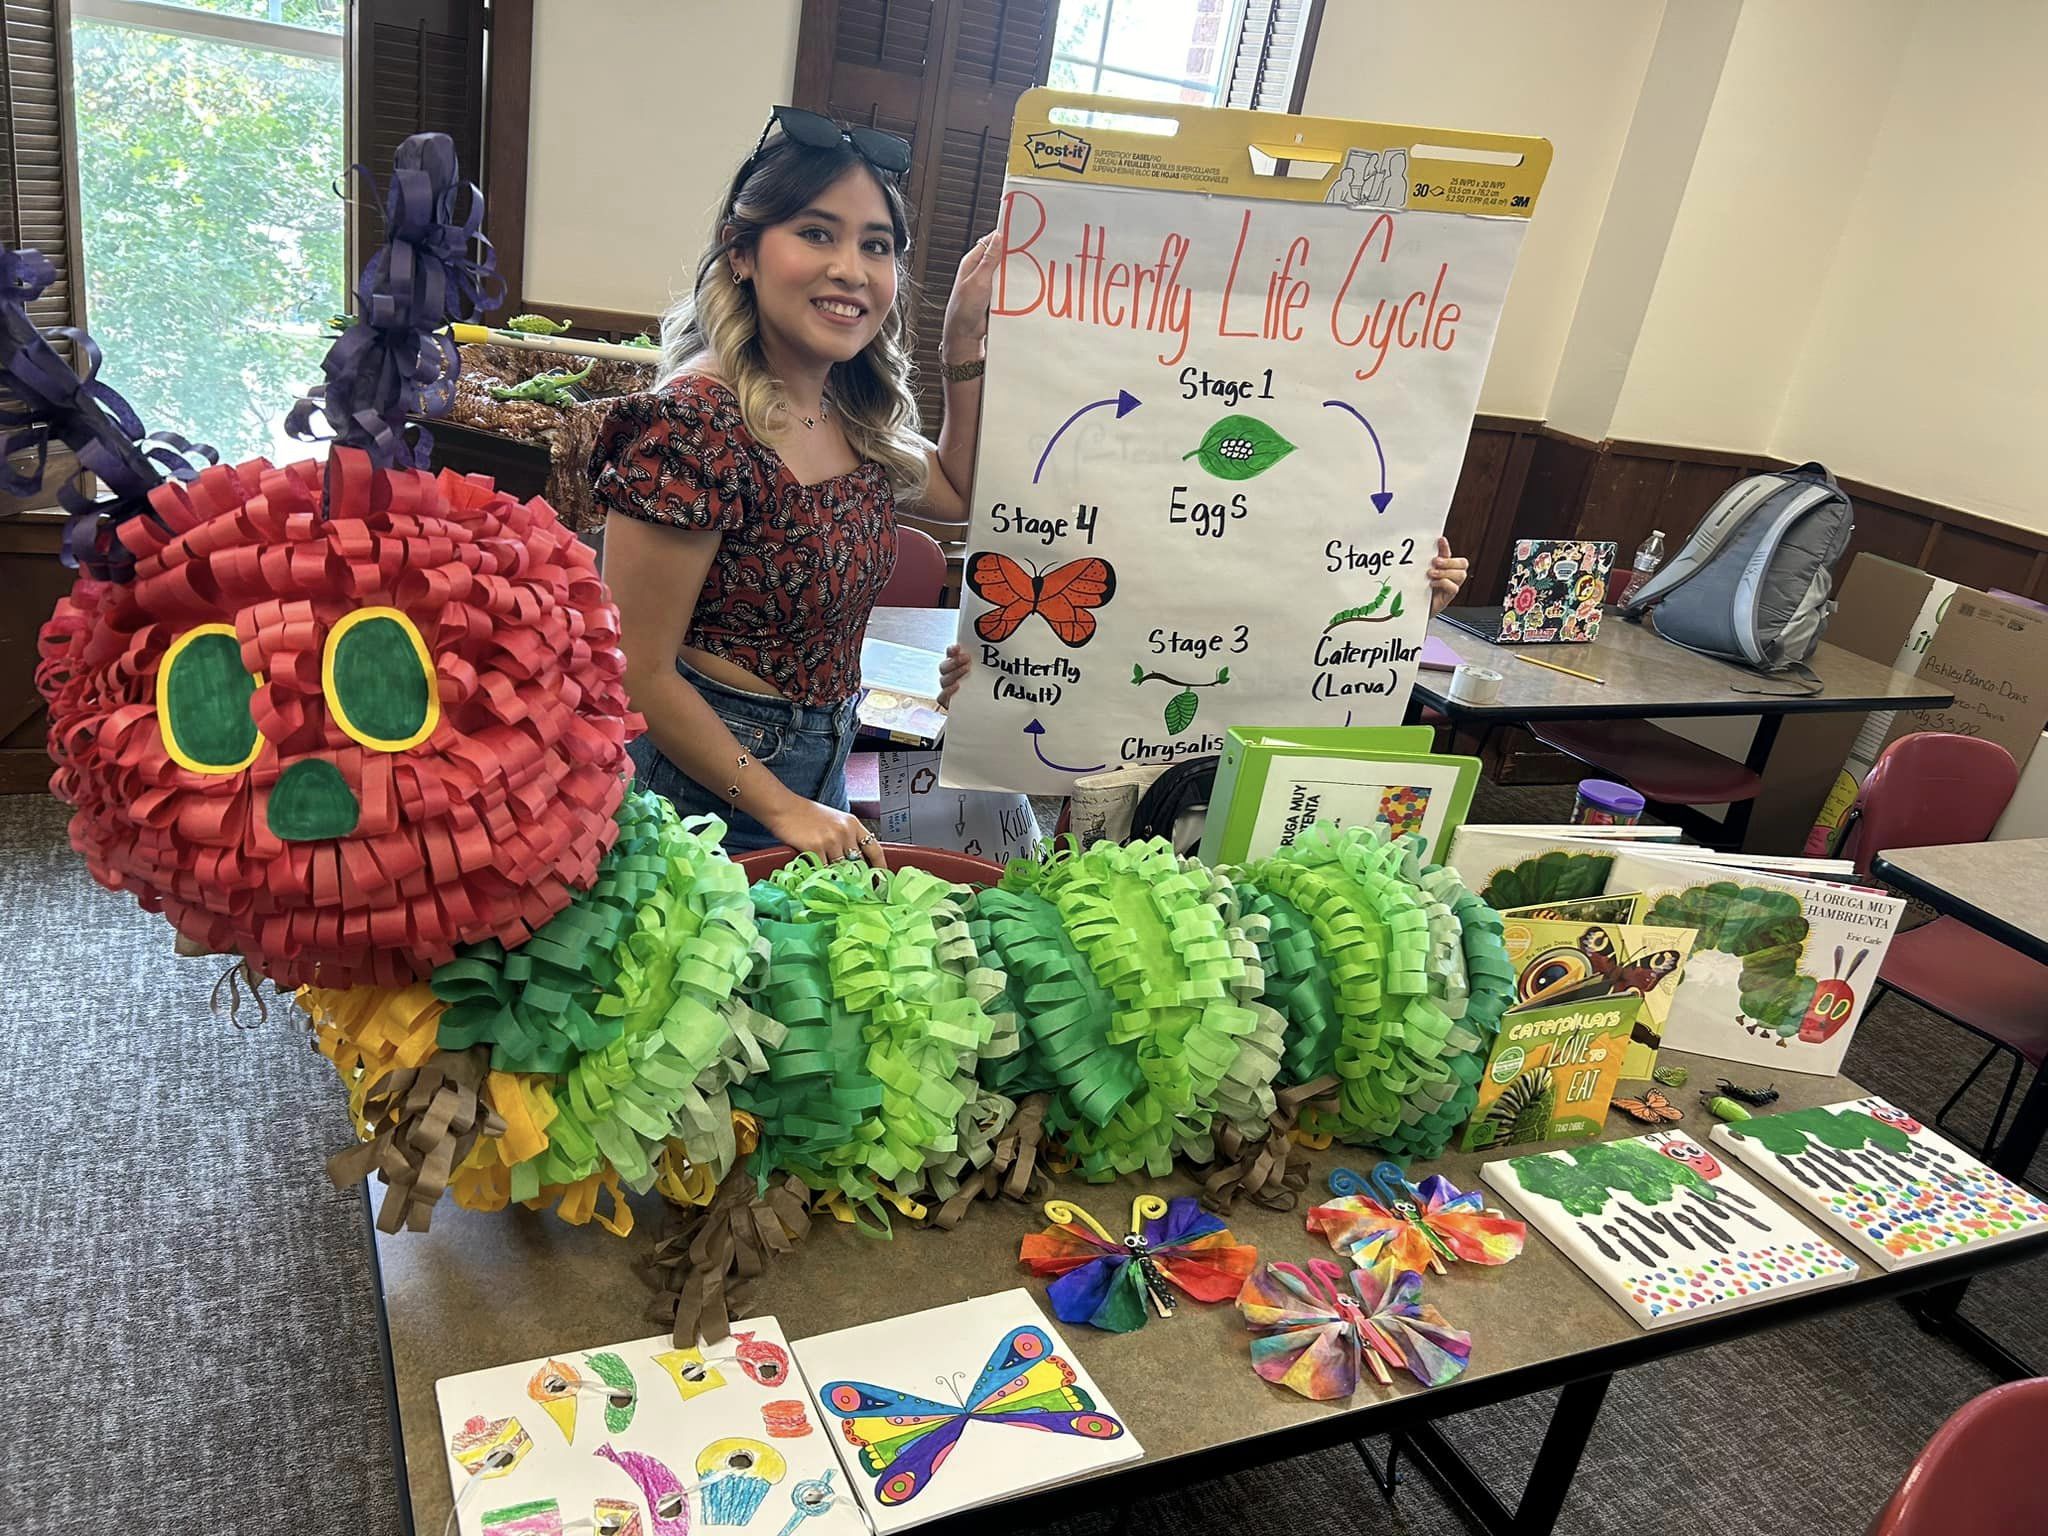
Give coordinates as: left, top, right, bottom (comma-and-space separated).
1841, 731, 2048, 1157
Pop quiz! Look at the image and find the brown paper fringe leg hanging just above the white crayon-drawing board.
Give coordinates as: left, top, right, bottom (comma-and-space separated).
645, 1165, 811, 1350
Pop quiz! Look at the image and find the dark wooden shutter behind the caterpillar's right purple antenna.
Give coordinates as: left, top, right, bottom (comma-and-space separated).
348, 0, 485, 280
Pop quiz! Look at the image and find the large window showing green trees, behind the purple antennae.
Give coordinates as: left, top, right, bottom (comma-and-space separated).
72, 0, 344, 461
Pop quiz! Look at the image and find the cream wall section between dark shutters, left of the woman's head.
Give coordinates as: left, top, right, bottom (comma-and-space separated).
526, 0, 801, 313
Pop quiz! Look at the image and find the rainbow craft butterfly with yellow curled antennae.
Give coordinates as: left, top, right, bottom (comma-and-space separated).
1018, 1194, 1260, 1333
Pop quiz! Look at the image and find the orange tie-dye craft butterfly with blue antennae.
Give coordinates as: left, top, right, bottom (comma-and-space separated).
1309, 1163, 1528, 1282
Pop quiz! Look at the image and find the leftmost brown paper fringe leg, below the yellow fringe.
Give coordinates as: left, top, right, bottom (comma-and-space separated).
328, 1044, 506, 1233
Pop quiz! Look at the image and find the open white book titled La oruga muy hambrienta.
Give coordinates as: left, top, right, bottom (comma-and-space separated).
1448, 825, 1905, 1075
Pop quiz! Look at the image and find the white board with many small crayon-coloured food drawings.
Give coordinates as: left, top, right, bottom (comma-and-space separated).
434, 1317, 866, 1536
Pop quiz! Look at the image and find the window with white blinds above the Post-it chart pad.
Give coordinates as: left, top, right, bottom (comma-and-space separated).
1047, 0, 1321, 113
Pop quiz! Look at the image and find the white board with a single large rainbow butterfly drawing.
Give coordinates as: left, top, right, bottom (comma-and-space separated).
797, 1290, 1145, 1536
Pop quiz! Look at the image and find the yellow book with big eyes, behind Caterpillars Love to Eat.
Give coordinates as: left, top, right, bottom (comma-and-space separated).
1501, 913, 1696, 1081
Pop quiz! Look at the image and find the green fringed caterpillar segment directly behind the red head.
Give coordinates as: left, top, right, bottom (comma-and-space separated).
432, 791, 780, 1200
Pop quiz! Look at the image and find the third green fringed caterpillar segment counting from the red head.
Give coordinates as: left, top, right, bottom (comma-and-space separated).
977, 840, 1280, 1182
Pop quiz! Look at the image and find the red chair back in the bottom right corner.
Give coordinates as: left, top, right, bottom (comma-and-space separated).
1870, 1376, 2048, 1536
